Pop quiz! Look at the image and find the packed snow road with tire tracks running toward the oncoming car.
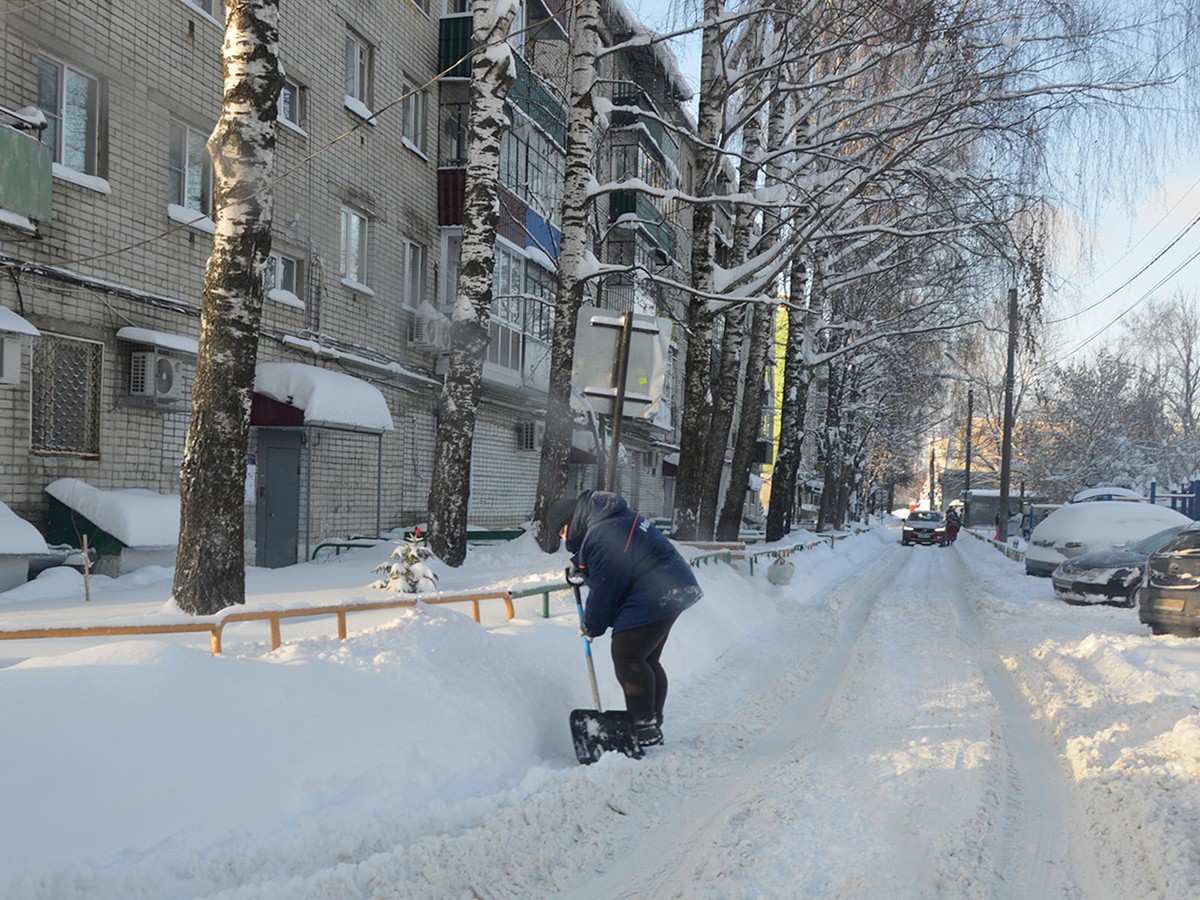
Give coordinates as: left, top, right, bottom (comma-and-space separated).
262, 532, 1145, 900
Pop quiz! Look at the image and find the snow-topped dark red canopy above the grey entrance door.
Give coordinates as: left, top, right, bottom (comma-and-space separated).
254, 362, 395, 434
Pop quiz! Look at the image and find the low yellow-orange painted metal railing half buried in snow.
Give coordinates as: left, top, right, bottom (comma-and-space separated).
0, 590, 515, 655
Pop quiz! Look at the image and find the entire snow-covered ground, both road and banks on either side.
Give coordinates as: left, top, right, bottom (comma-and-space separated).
0, 527, 1200, 900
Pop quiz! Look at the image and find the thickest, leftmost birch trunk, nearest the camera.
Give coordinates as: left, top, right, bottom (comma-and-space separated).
172, 0, 283, 616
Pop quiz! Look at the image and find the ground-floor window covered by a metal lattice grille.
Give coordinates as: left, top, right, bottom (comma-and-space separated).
30, 332, 104, 456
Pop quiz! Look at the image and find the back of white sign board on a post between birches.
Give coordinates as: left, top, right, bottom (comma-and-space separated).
571, 306, 671, 420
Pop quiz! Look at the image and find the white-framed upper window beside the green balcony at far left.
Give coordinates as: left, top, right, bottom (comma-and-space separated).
37, 56, 100, 175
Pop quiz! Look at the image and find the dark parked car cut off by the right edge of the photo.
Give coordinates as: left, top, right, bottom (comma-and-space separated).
1138, 524, 1200, 637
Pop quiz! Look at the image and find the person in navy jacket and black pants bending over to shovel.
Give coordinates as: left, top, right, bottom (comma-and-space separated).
546, 491, 702, 746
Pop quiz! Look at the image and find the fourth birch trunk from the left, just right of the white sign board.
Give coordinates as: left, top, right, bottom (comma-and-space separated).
673, 0, 726, 540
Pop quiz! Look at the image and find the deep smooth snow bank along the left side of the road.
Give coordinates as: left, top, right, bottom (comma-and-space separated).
0, 538, 796, 898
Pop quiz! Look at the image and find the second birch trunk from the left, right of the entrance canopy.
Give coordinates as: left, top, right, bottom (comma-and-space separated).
428, 0, 516, 566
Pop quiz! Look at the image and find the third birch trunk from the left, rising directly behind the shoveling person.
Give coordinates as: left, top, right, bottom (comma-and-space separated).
533, 0, 600, 553
